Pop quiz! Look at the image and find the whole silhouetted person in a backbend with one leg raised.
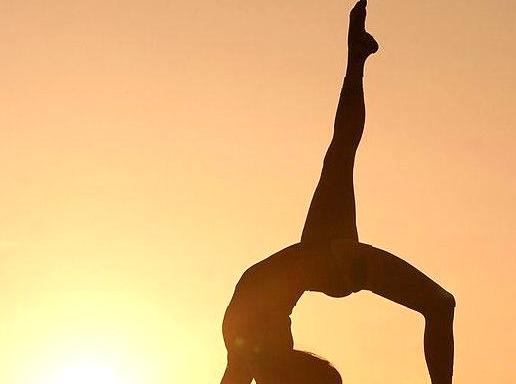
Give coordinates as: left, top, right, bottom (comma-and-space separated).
222, 0, 455, 384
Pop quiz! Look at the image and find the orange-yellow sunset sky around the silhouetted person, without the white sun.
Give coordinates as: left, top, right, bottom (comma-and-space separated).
0, 0, 516, 384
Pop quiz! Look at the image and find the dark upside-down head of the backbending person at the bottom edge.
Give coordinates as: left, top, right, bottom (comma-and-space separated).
253, 350, 342, 384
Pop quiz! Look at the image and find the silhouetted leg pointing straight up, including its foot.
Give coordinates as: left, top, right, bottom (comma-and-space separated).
301, 0, 378, 246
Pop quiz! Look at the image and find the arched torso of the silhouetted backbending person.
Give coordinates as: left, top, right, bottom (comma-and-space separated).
223, 244, 360, 349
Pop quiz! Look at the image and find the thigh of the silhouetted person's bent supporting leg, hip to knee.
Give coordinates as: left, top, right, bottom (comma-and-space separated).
359, 244, 453, 314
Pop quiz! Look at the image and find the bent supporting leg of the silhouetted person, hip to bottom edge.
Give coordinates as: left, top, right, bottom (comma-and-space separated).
359, 245, 455, 384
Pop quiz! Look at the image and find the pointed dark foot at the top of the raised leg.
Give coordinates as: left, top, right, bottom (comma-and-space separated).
348, 0, 378, 61
